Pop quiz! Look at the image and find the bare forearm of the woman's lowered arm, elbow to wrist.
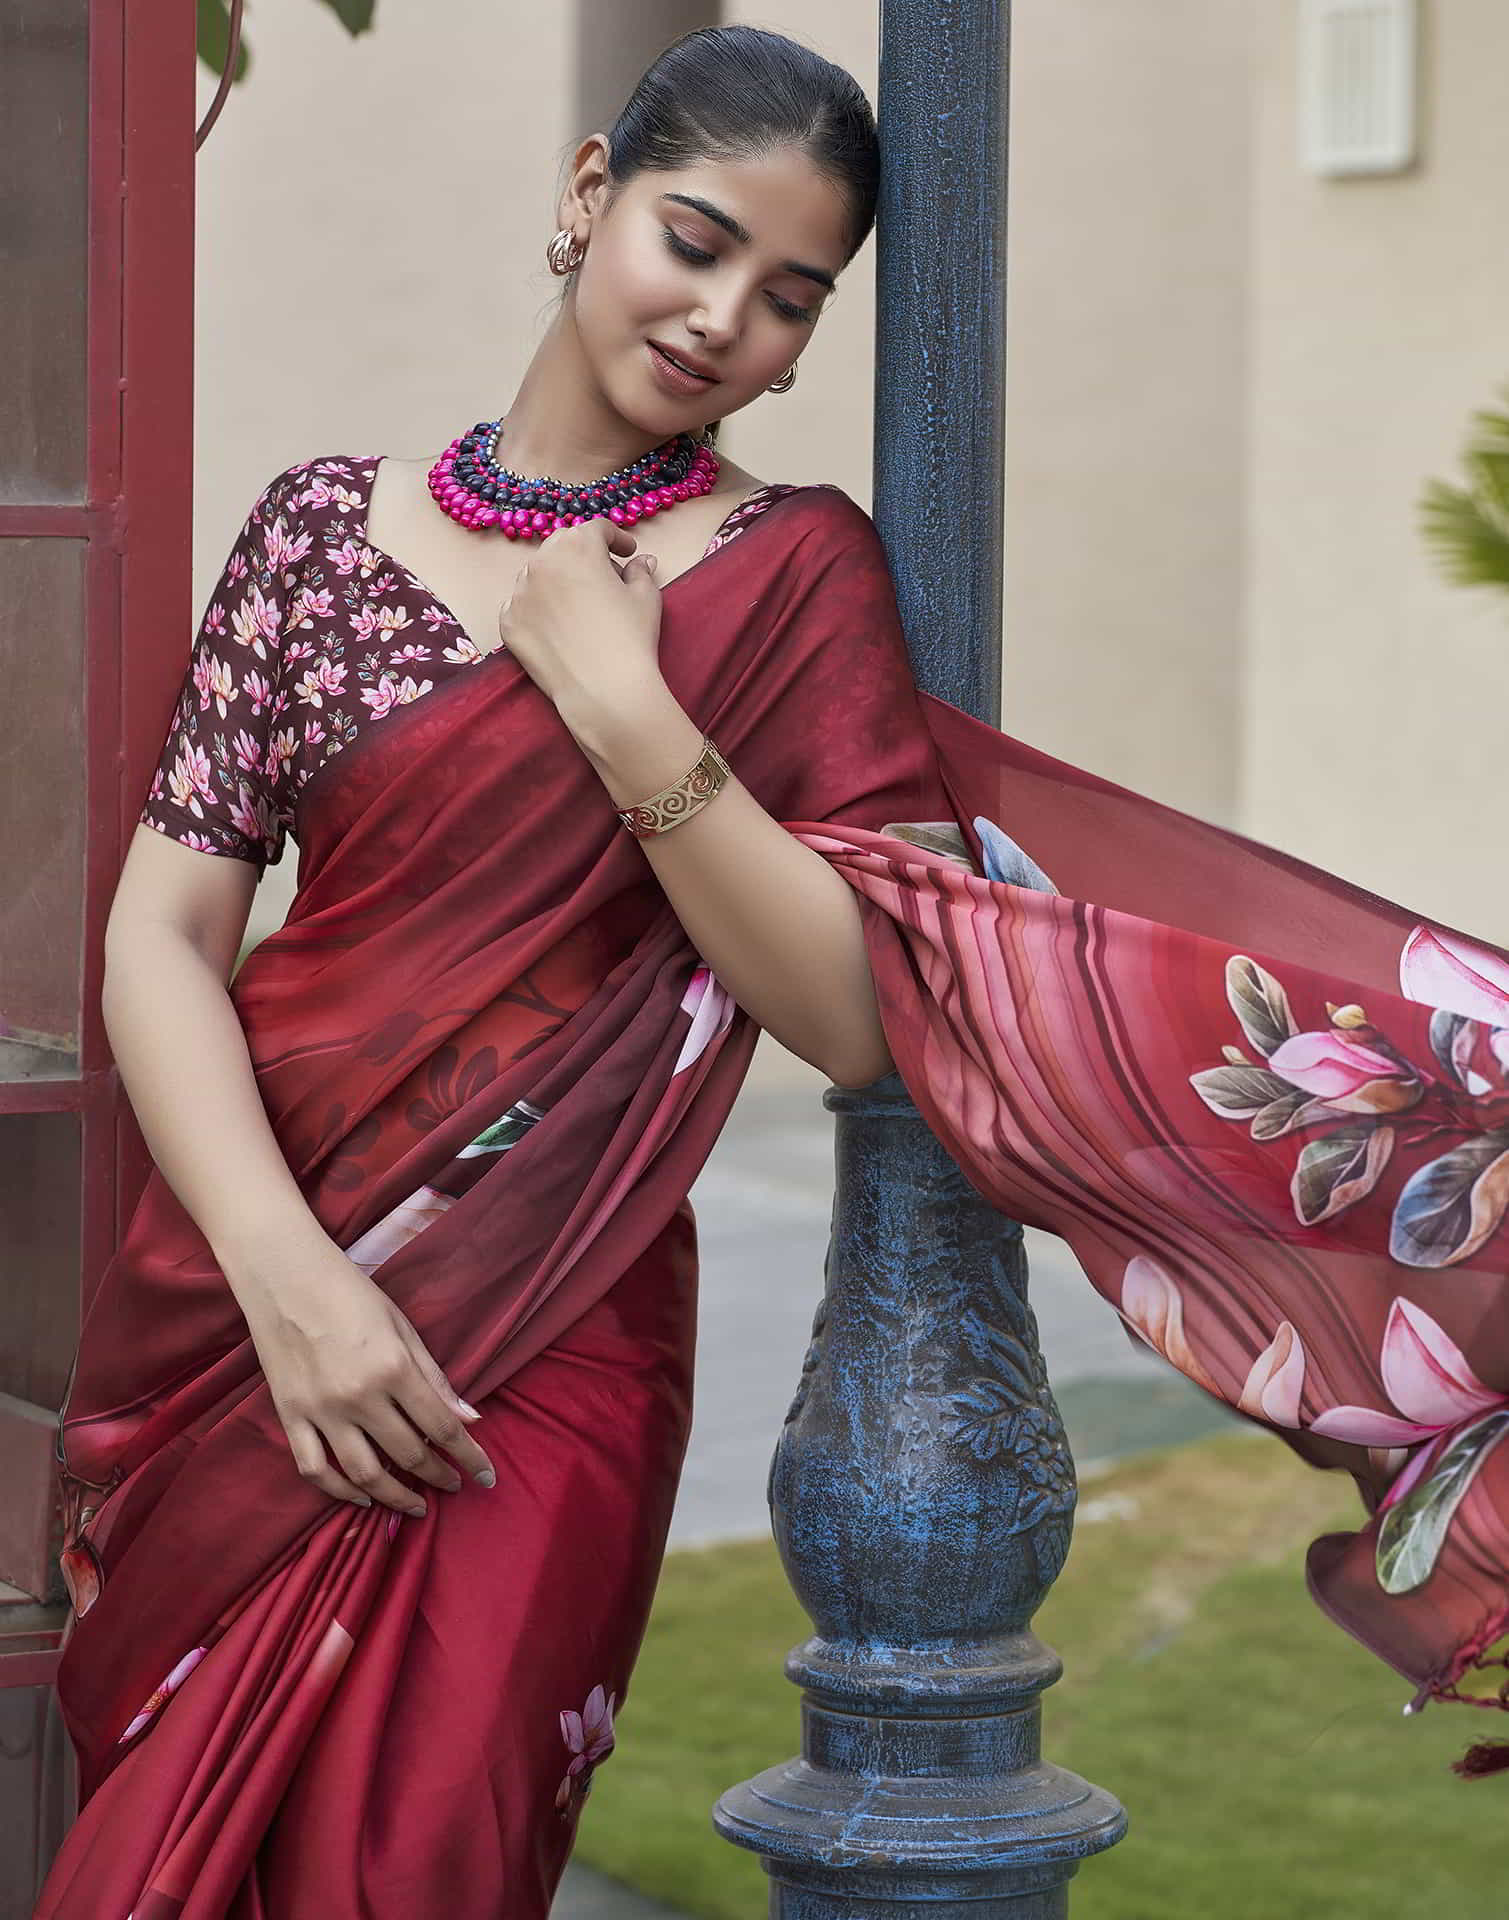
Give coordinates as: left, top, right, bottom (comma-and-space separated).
100, 927, 324, 1300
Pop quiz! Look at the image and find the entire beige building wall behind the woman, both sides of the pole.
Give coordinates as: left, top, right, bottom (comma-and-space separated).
194, 0, 1509, 960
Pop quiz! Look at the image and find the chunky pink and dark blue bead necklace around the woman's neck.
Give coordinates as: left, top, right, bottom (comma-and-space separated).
430, 420, 718, 540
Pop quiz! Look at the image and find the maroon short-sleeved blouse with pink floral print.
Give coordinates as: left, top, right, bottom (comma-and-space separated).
140, 453, 793, 872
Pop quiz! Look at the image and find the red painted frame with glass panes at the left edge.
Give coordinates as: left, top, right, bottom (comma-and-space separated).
0, 0, 196, 1688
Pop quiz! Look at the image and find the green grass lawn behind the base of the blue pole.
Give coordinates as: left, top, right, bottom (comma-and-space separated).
576, 1430, 1509, 1920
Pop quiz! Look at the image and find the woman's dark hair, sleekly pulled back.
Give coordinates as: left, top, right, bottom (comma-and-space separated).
575, 27, 879, 436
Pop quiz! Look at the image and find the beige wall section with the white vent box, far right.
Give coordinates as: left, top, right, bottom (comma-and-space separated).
1242, 0, 1509, 941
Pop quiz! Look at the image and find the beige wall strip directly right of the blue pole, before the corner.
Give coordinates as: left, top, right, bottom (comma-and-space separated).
1002, 0, 1244, 826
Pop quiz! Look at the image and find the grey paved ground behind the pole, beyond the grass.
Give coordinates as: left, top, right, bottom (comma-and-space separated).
553, 1037, 1231, 1920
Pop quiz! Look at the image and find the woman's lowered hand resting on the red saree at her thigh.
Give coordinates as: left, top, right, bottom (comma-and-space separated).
227, 1238, 495, 1515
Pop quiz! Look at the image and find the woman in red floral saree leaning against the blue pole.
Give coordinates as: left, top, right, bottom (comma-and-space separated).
36, 18, 1509, 1920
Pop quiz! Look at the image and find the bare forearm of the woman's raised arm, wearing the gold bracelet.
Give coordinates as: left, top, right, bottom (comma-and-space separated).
563, 682, 893, 1087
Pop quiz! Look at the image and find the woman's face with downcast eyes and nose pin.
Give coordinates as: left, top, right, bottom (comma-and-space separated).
563, 136, 849, 438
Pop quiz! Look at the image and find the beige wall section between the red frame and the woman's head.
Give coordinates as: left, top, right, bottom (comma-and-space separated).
194, 0, 574, 605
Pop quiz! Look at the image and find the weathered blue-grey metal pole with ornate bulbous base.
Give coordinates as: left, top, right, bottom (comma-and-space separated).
712, 0, 1127, 1920
